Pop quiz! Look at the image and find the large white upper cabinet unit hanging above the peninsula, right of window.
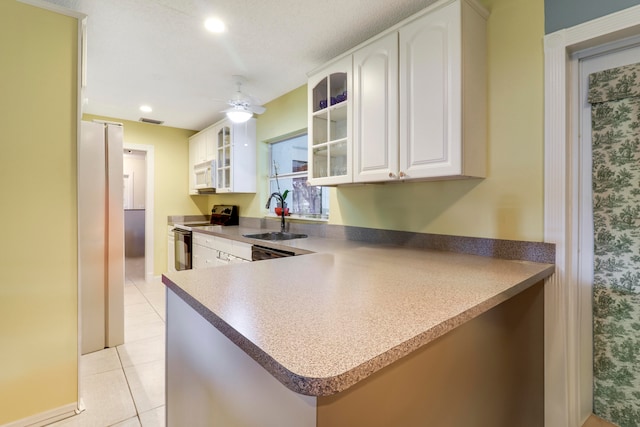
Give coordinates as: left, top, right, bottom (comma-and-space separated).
309, 0, 488, 185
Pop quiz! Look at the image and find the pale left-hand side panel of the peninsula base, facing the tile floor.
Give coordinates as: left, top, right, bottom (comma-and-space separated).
166, 290, 317, 427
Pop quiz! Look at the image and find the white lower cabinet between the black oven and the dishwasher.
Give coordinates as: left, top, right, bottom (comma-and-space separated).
191, 232, 251, 269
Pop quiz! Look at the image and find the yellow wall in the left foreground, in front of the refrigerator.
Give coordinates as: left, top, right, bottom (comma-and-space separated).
0, 0, 78, 425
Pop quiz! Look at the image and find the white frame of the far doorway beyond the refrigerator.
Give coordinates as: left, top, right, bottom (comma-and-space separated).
124, 141, 155, 282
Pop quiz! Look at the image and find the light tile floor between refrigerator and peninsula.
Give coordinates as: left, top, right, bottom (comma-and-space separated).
52, 258, 165, 427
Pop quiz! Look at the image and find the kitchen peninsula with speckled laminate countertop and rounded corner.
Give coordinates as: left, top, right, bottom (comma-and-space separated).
163, 227, 554, 427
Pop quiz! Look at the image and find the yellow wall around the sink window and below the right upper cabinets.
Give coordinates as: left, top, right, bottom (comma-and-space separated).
238, 0, 544, 241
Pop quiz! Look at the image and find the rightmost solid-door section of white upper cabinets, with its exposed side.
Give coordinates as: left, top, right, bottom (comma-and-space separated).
398, 1, 487, 179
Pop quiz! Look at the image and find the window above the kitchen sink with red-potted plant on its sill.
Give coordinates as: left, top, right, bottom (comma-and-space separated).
269, 133, 329, 219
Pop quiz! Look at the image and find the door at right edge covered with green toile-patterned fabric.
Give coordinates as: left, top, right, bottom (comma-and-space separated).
576, 42, 640, 427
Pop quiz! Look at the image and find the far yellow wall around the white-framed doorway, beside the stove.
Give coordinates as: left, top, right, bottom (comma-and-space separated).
83, 114, 201, 275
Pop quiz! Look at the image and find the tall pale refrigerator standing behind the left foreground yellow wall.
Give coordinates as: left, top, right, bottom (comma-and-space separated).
78, 121, 124, 354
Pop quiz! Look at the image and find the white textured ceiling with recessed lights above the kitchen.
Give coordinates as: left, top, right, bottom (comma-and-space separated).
46, 0, 434, 130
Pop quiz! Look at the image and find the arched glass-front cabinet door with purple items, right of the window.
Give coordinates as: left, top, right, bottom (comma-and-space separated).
308, 56, 352, 185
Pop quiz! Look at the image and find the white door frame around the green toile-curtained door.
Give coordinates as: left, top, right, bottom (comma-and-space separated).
544, 6, 640, 427
